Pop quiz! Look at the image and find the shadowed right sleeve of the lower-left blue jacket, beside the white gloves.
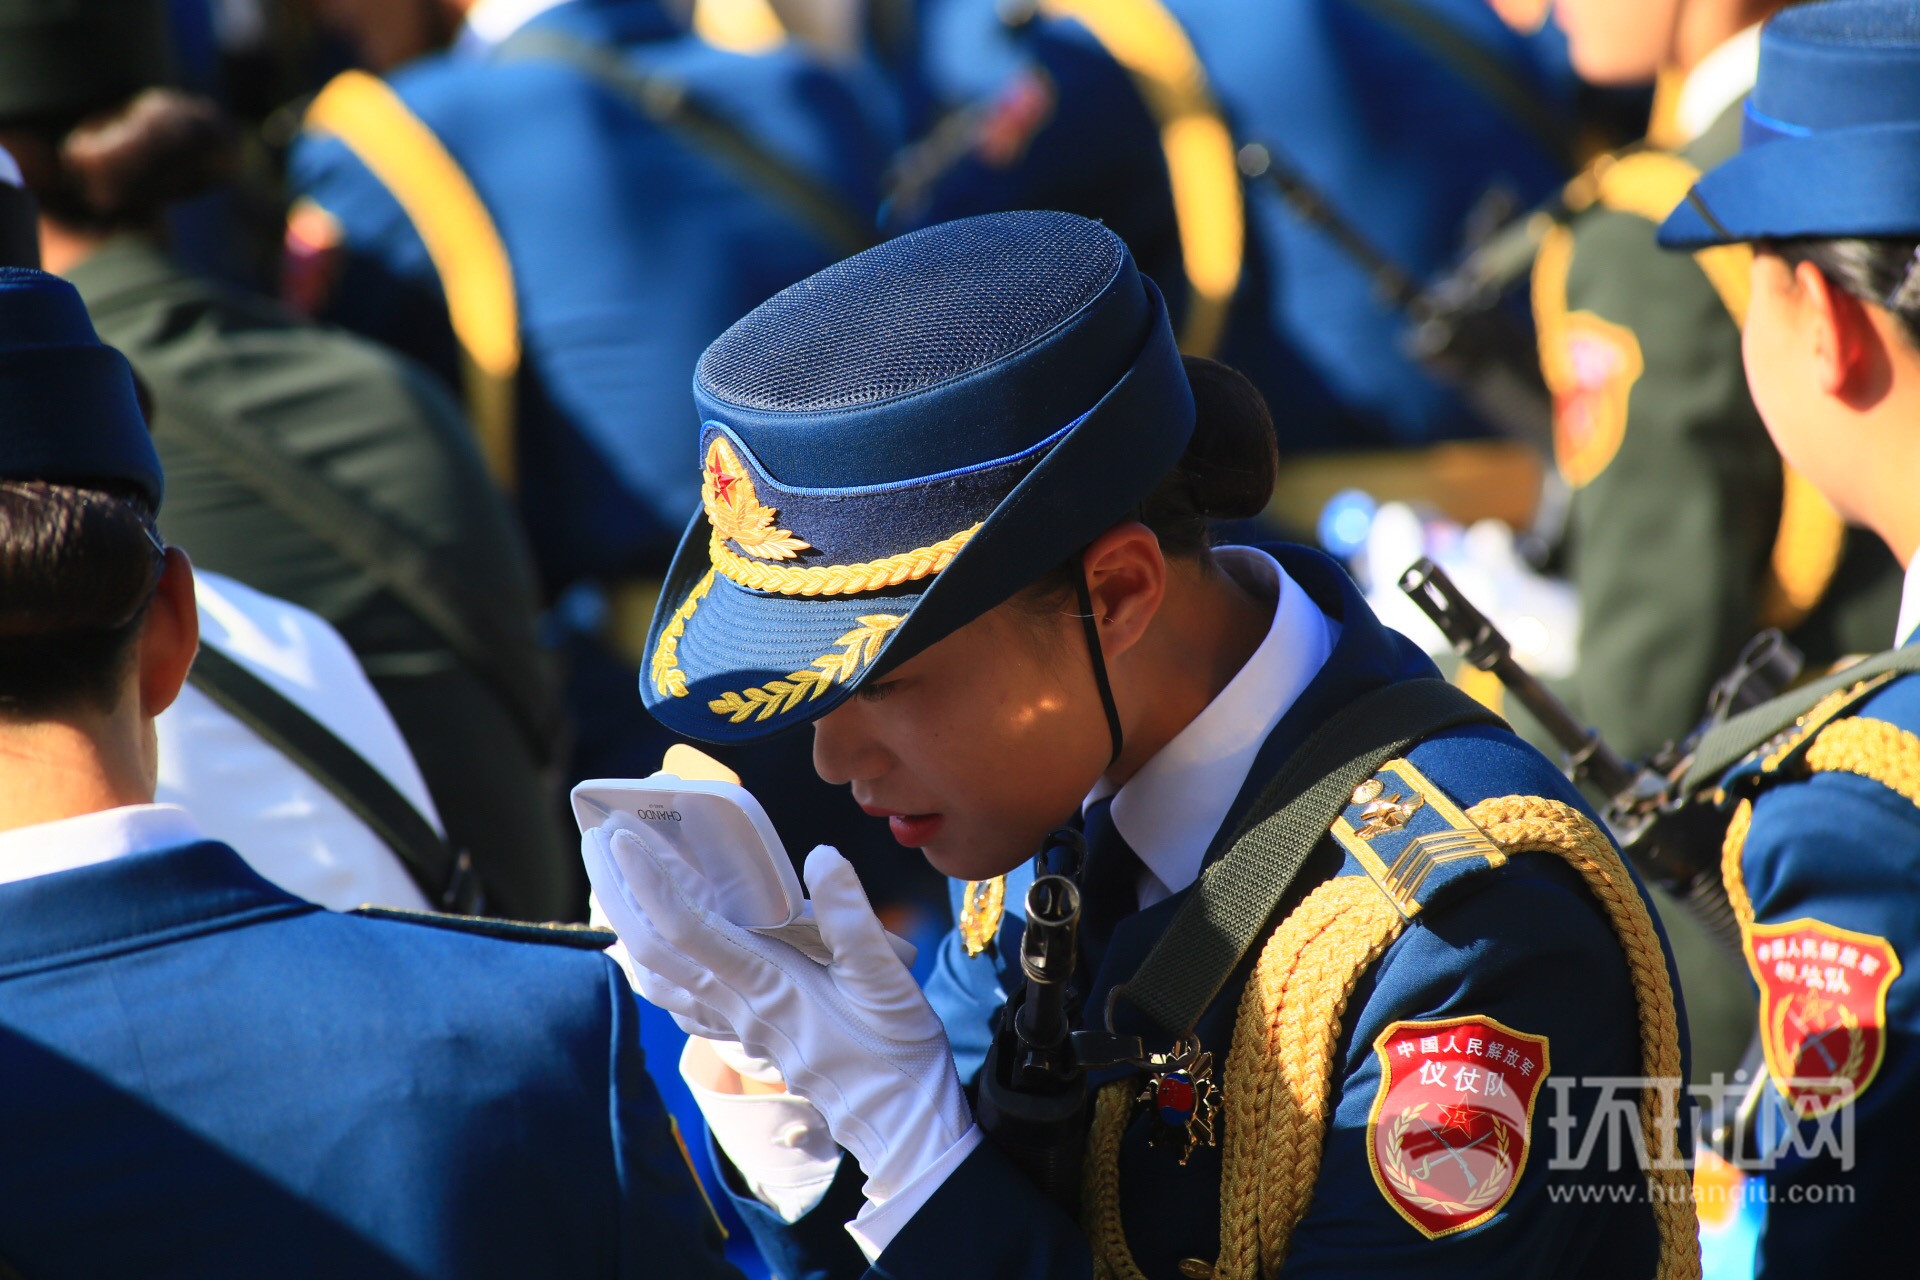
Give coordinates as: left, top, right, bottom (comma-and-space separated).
607, 960, 739, 1280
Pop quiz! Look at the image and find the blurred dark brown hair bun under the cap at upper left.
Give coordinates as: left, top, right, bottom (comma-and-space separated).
60, 88, 238, 226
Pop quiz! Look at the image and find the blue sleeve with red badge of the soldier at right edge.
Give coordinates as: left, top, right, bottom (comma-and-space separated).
1741, 767, 1920, 1276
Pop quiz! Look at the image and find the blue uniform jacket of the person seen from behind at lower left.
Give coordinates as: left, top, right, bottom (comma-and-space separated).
0, 842, 733, 1280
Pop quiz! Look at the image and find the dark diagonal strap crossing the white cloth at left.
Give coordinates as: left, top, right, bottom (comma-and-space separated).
188, 645, 478, 910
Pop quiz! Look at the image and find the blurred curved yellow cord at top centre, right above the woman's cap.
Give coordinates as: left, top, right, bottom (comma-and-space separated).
1041, 0, 1246, 355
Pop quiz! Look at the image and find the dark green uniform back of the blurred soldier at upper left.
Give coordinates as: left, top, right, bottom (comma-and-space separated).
69, 236, 584, 919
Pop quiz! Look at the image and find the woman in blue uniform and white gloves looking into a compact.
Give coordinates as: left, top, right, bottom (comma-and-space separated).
584, 213, 1697, 1276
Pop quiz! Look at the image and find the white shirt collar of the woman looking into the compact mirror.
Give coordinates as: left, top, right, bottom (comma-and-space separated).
1089, 547, 1340, 908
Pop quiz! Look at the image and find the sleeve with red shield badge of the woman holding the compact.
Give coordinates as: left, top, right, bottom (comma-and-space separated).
1286, 854, 1690, 1280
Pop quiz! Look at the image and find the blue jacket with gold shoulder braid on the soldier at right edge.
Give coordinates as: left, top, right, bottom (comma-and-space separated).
1726, 644, 1920, 1276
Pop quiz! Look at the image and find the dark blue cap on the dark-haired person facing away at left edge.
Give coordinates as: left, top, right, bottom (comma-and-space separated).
0, 267, 163, 509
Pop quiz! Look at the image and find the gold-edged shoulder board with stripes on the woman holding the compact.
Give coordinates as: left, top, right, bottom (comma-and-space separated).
1332, 760, 1507, 919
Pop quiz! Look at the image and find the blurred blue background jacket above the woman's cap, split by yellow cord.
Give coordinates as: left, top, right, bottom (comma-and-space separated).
895, 0, 1576, 451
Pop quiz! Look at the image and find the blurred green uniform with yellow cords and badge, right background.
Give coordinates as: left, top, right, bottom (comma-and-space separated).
1534, 104, 1901, 756
